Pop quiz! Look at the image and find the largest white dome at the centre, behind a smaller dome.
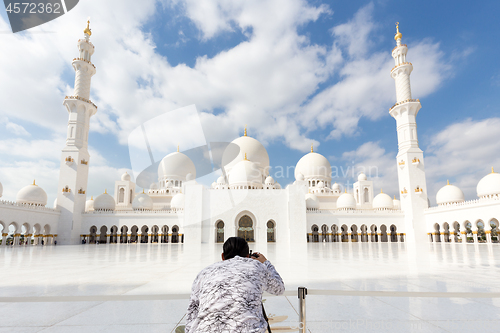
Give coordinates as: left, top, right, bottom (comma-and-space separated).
222, 135, 269, 175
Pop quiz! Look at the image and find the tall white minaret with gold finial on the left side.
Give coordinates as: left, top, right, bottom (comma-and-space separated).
57, 22, 97, 244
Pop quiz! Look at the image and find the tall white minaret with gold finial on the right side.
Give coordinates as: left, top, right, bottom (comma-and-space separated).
389, 22, 428, 242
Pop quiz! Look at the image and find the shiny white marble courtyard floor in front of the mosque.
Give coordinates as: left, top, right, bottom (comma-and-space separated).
0, 243, 500, 333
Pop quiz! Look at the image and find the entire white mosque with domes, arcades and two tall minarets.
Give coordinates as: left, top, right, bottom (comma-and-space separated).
0, 20, 500, 246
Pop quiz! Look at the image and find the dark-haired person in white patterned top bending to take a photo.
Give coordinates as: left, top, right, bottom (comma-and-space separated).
185, 237, 285, 333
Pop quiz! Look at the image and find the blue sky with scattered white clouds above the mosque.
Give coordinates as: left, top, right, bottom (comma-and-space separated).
0, 0, 500, 205
